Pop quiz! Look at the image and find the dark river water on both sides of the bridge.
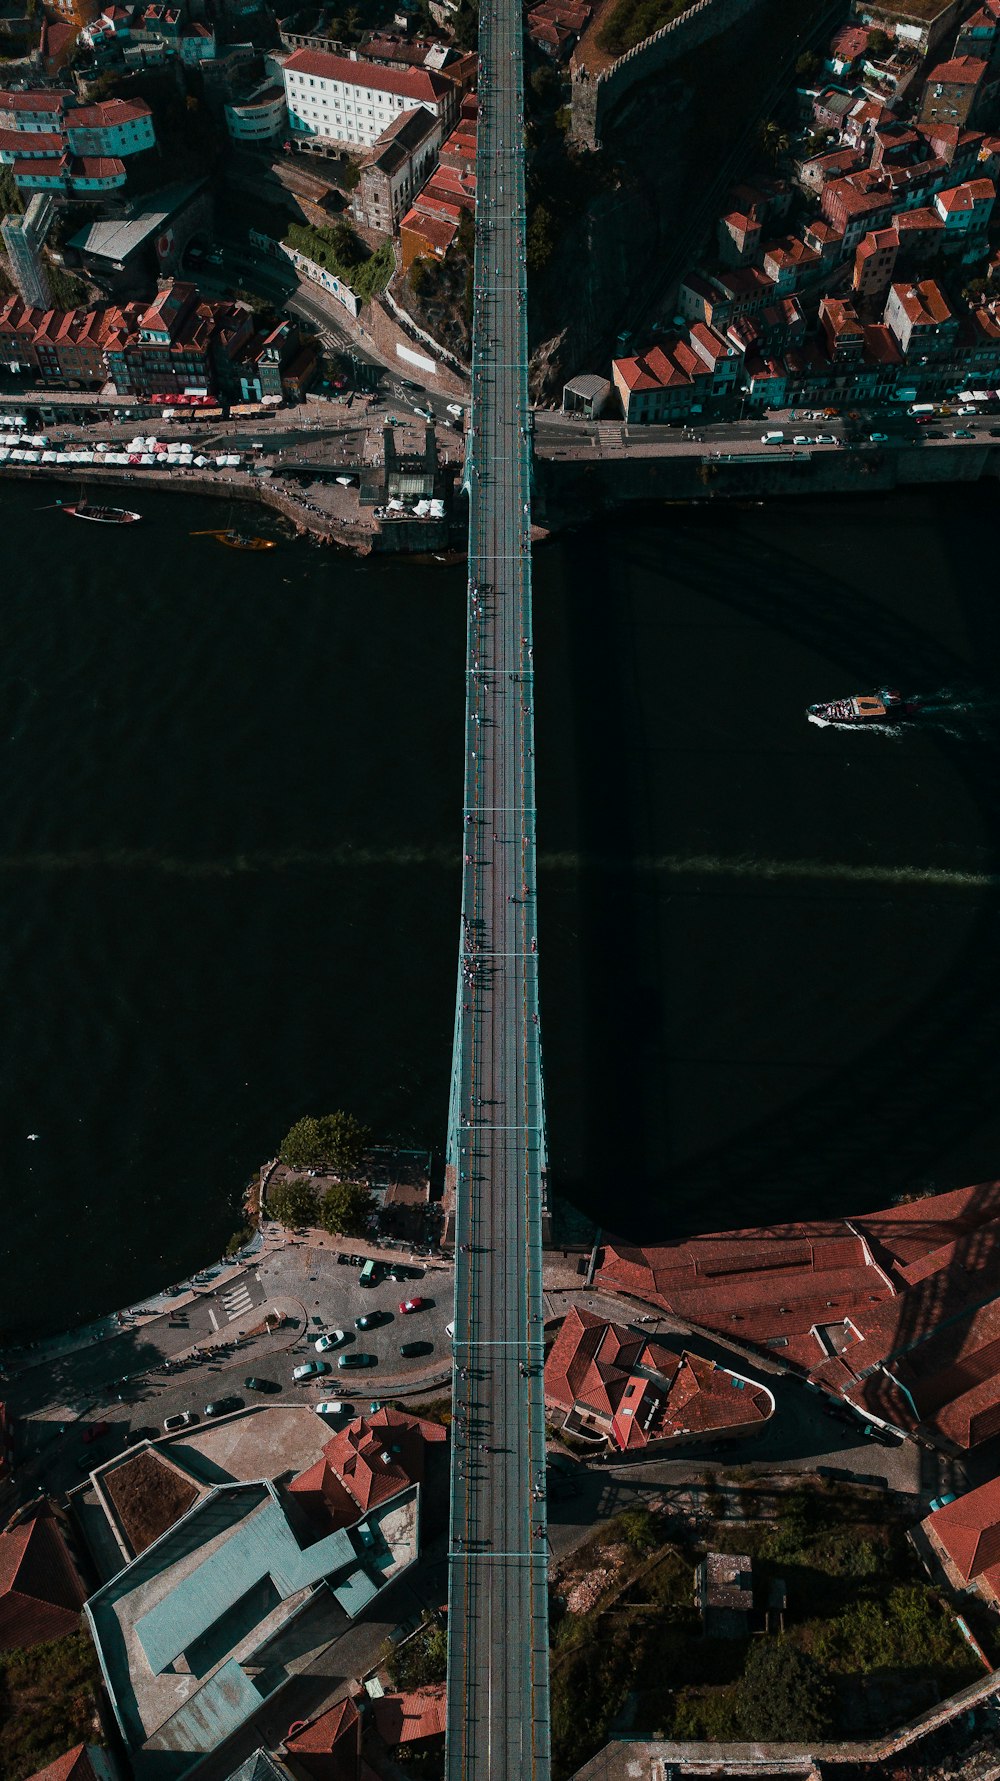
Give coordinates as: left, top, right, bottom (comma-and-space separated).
0, 484, 1000, 1327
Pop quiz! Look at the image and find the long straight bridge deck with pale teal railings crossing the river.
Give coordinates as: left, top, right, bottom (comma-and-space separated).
446, 0, 549, 1781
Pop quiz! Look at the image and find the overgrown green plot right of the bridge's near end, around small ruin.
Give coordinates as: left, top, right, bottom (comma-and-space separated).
553, 1480, 980, 1781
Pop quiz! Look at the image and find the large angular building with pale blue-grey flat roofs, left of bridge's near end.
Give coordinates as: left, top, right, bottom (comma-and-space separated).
86, 1480, 417, 1777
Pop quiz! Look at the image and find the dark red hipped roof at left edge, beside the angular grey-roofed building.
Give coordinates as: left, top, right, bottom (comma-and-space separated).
0, 1509, 86, 1651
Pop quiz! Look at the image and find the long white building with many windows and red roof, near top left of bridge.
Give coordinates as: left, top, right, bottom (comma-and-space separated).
282, 50, 458, 148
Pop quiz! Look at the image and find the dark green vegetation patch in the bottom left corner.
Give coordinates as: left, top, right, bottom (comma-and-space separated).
0, 1633, 103, 1781
